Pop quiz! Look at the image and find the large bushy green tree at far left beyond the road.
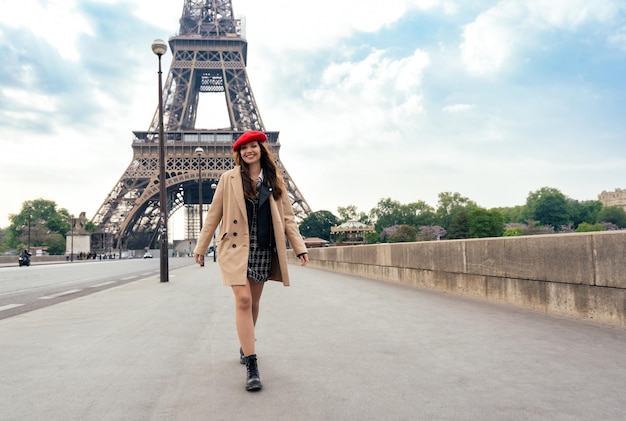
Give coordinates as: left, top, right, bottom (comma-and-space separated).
7, 199, 71, 254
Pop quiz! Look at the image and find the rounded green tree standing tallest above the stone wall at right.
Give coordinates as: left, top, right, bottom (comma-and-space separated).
526, 187, 570, 232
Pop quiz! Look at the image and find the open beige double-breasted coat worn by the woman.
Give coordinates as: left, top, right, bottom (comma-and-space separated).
193, 166, 306, 286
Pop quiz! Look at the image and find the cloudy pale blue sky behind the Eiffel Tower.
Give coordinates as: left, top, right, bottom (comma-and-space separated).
0, 0, 626, 236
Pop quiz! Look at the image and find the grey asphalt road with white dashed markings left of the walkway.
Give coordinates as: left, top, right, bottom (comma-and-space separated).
0, 257, 193, 320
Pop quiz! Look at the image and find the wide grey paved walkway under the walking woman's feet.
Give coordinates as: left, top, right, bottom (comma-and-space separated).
0, 262, 626, 421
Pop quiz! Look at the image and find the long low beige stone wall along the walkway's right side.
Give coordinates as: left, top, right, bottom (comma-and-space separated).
291, 231, 626, 327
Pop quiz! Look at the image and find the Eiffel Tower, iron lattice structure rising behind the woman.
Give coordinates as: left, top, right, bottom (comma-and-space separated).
92, 0, 311, 251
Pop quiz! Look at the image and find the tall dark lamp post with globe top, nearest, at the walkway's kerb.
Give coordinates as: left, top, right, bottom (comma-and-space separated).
152, 39, 169, 282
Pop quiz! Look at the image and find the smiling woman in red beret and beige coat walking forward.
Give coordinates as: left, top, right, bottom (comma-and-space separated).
194, 131, 309, 391
